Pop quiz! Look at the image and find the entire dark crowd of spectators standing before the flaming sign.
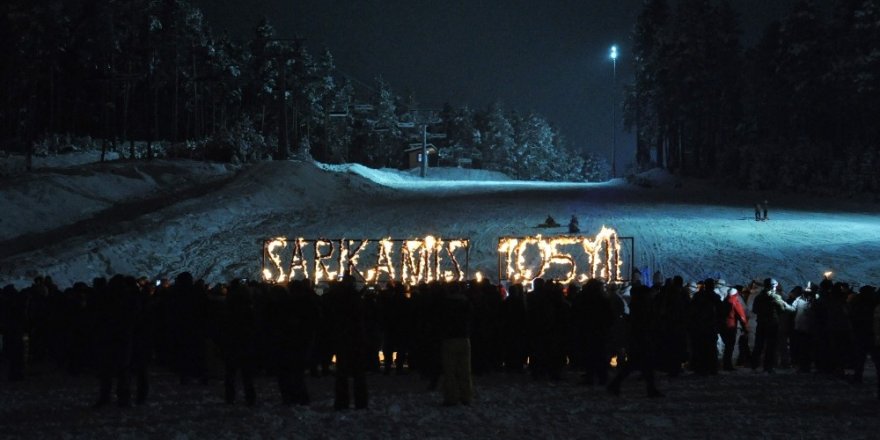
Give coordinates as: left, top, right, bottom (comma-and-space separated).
0, 272, 880, 410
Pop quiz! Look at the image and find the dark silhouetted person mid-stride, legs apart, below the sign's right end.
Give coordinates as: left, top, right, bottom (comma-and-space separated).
608, 283, 663, 397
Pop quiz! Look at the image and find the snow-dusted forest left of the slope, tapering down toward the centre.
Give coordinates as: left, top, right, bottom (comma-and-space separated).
0, 0, 608, 181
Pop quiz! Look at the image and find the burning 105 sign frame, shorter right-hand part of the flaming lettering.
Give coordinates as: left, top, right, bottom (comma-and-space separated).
498, 227, 623, 283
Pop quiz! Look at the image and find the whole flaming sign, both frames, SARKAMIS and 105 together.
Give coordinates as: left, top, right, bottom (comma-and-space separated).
262, 227, 633, 285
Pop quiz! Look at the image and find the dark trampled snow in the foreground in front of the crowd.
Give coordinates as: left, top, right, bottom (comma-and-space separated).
0, 362, 880, 440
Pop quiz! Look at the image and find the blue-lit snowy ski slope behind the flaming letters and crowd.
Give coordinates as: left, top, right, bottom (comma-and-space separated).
0, 157, 880, 287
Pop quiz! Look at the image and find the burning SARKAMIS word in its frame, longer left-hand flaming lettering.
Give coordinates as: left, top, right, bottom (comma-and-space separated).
262, 236, 470, 285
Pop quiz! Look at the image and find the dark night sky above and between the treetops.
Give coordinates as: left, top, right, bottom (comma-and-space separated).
196, 0, 794, 170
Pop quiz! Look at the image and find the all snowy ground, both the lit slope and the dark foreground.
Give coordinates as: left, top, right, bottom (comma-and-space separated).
0, 156, 880, 439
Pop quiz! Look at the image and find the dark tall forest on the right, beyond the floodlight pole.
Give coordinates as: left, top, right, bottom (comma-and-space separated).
623, 0, 880, 194
